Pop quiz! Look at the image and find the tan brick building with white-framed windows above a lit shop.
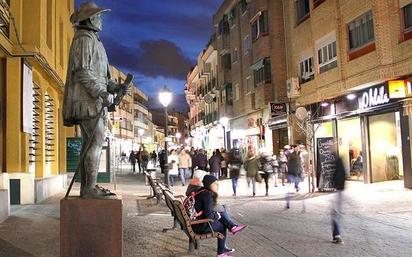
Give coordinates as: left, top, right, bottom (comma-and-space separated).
283, 0, 412, 188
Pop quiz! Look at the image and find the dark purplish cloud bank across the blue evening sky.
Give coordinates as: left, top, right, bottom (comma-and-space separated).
102, 38, 195, 80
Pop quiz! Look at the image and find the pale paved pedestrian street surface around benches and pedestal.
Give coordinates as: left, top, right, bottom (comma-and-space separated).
0, 171, 412, 257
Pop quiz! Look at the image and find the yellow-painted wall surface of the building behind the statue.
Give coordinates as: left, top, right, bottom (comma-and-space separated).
0, 0, 74, 178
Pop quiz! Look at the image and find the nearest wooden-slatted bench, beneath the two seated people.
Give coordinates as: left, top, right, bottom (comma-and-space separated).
173, 200, 224, 250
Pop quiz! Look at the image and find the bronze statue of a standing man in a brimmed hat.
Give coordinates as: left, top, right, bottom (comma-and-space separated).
63, 2, 122, 198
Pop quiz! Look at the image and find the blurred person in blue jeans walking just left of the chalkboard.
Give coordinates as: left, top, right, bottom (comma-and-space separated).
286, 145, 302, 209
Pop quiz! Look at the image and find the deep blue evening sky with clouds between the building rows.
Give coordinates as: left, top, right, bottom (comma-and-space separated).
75, 0, 223, 111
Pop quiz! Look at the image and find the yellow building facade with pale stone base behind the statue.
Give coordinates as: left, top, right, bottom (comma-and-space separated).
0, 0, 75, 219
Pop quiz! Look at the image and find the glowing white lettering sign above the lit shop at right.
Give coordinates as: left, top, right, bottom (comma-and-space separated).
358, 85, 390, 109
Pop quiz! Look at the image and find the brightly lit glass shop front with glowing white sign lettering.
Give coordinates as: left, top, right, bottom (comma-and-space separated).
310, 81, 412, 188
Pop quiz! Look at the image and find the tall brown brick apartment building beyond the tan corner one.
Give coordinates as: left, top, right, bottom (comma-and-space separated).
213, 0, 288, 152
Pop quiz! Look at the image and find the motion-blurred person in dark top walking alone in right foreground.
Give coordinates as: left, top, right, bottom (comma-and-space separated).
332, 156, 346, 244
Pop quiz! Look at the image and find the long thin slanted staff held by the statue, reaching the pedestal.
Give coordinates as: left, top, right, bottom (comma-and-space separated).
64, 74, 133, 199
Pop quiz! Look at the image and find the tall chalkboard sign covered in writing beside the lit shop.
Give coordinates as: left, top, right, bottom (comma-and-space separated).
316, 137, 338, 191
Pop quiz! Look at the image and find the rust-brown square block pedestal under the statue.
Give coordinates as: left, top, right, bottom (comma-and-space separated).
60, 198, 123, 257
